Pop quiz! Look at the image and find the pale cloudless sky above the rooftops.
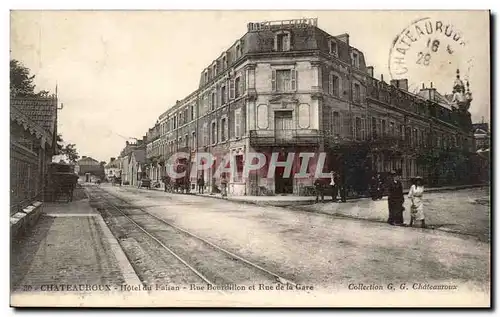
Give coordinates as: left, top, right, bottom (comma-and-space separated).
10, 10, 491, 161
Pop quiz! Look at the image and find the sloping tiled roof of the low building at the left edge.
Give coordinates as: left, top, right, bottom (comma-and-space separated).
10, 96, 57, 135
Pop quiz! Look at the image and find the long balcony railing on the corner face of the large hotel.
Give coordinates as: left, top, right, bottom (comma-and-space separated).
250, 129, 321, 146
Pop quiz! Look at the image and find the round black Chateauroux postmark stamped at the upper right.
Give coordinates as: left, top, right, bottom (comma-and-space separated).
389, 17, 473, 90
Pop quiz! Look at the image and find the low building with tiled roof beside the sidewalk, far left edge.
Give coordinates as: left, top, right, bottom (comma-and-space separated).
10, 95, 57, 213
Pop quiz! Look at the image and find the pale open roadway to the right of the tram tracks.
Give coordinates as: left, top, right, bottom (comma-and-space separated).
93, 185, 489, 290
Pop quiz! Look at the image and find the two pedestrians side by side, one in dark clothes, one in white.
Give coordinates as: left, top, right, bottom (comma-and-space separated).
387, 172, 426, 228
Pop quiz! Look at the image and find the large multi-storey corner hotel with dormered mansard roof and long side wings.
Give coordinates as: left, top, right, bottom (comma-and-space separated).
147, 19, 472, 195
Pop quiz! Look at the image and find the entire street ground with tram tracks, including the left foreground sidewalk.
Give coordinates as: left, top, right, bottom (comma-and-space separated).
12, 184, 490, 306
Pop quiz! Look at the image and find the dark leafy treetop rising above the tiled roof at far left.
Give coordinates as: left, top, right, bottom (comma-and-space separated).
10, 59, 49, 97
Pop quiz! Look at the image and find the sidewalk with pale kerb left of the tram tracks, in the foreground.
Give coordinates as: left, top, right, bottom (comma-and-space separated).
11, 193, 140, 294
